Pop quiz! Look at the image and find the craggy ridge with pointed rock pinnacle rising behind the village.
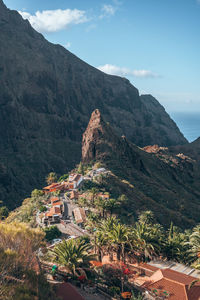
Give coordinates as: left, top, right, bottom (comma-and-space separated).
82, 110, 200, 228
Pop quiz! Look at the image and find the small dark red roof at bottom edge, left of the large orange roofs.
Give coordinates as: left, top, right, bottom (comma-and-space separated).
56, 282, 85, 300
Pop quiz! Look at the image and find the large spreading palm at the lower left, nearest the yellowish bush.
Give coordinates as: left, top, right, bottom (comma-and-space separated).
51, 239, 96, 275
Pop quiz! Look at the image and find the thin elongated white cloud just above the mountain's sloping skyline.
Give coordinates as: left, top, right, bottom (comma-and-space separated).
98, 64, 159, 78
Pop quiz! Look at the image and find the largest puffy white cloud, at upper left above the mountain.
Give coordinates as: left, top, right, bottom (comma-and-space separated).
19, 9, 89, 32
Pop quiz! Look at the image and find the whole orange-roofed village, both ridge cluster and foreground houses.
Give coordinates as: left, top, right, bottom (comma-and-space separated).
31, 168, 200, 300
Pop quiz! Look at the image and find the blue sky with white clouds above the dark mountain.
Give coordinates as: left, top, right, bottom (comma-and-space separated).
4, 0, 200, 113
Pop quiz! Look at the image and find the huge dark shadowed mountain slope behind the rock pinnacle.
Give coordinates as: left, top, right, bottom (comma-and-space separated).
0, 0, 187, 208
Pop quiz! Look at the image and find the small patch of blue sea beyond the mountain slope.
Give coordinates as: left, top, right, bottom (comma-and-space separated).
170, 112, 200, 142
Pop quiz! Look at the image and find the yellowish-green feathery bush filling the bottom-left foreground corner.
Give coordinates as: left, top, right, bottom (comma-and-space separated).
0, 223, 47, 300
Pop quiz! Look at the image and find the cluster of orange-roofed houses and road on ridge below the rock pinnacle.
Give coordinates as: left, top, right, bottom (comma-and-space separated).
36, 168, 109, 242
